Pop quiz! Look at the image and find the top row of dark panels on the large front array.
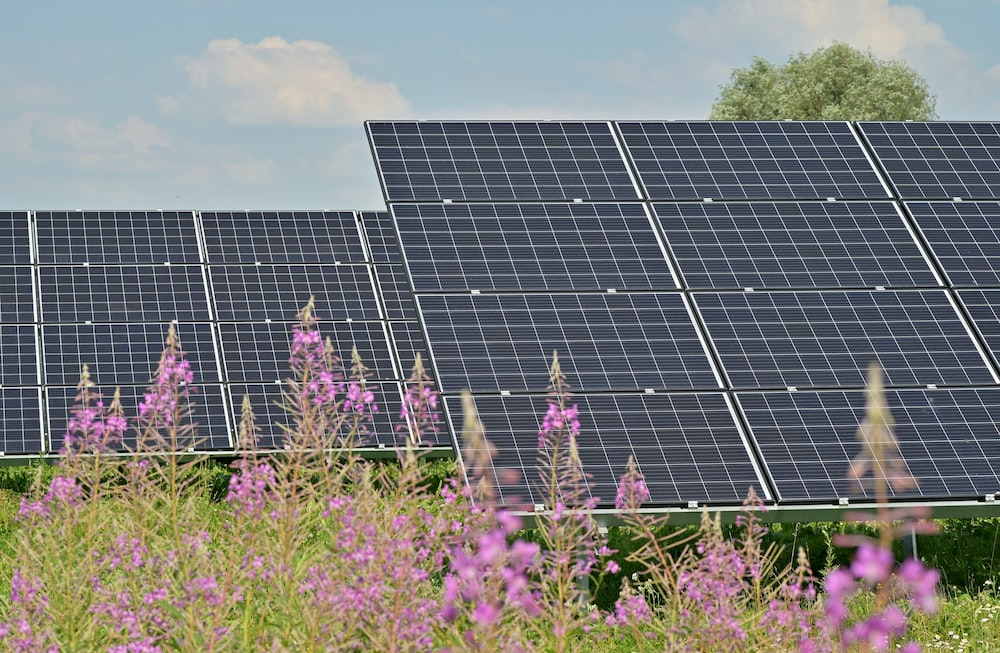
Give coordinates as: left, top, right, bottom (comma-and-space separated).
366, 121, 1000, 203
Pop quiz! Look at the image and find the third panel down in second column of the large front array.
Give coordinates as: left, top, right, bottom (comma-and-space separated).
695, 290, 996, 388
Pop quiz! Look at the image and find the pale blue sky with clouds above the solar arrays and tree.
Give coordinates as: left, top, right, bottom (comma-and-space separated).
0, 0, 1000, 210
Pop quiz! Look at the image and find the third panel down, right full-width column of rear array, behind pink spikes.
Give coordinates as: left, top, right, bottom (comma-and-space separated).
219, 322, 399, 383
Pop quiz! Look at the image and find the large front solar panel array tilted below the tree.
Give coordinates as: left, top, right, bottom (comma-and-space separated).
367, 121, 1000, 506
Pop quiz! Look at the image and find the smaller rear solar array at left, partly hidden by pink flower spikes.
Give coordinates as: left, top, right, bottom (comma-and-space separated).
0, 211, 423, 456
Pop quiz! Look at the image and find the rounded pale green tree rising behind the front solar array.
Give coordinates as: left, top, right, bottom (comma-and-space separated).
709, 42, 936, 120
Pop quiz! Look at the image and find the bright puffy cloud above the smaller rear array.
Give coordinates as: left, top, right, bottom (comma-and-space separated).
166, 36, 410, 127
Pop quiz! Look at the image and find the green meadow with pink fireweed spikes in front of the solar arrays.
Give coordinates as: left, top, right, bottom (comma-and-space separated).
0, 298, 1000, 653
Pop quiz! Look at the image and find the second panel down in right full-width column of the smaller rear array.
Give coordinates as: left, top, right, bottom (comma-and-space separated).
209, 265, 379, 321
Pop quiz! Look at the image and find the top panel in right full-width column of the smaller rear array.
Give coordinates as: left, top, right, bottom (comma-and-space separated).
201, 211, 365, 264
